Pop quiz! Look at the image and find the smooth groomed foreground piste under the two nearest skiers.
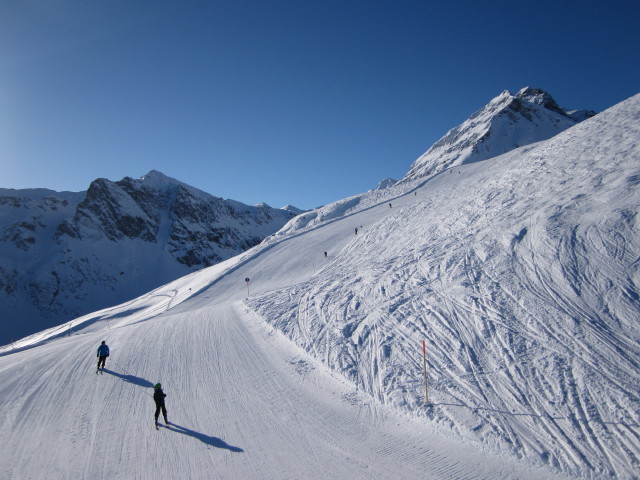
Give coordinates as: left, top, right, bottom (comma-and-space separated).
0, 304, 564, 479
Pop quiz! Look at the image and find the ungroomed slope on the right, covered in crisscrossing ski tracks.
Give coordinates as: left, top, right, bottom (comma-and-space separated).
250, 92, 640, 476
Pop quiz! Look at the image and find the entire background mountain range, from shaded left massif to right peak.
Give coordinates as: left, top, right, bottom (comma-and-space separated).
0, 87, 595, 344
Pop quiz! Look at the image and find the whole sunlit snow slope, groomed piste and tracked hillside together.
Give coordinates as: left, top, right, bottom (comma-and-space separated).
0, 92, 640, 479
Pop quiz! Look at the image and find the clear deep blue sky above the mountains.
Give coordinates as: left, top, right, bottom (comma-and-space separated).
0, 0, 640, 208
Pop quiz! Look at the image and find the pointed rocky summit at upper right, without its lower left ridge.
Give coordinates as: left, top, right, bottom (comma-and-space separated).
403, 87, 596, 180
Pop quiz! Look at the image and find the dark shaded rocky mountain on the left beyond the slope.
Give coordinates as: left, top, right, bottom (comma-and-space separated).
0, 171, 296, 344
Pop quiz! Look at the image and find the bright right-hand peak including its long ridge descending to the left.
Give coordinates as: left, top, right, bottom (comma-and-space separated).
278, 87, 596, 235
